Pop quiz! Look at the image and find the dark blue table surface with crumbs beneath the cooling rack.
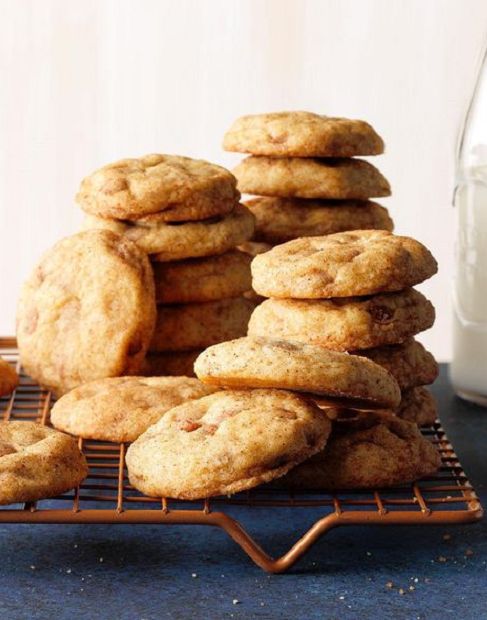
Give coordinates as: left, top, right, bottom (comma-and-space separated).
0, 368, 487, 620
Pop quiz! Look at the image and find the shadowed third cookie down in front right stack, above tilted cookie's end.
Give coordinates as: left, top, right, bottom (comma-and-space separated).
359, 338, 439, 390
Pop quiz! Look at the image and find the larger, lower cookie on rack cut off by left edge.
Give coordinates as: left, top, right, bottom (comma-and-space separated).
0, 422, 88, 505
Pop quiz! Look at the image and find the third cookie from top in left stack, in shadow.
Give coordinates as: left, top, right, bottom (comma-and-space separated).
153, 250, 252, 304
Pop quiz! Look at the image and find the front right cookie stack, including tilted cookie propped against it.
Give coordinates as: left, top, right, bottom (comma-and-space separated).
175, 230, 441, 490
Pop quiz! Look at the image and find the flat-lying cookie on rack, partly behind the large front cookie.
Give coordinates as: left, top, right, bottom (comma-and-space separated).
51, 377, 215, 443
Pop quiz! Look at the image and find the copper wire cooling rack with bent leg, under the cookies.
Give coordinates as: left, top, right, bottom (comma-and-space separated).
0, 338, 482, 573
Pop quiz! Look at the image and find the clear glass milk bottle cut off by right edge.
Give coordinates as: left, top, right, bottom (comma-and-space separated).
450, 49, 487, 407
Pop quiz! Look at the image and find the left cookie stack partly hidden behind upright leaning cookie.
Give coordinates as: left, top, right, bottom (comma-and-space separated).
77, 155, 255, 375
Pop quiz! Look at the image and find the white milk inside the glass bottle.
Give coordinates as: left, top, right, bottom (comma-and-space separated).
450, 165, 487, 406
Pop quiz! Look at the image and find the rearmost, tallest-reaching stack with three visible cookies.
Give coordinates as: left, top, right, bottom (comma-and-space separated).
223, 112, 393, 245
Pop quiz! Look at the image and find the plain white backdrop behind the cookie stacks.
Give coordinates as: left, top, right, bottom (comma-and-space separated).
0, 0, 487, 359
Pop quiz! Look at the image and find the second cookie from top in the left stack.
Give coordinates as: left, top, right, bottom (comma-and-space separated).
83, 205, 254, 261
